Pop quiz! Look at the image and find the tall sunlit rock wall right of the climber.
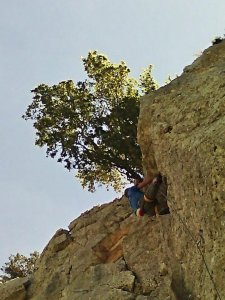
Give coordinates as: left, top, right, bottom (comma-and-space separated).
138, 42, 225, 300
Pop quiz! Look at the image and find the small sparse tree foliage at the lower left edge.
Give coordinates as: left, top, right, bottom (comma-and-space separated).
0, 251, 39, 282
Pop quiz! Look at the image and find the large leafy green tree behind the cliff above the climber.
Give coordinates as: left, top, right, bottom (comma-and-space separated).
23, 51, 157, 191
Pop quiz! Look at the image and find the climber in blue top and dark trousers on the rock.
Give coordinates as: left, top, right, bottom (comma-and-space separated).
124, 174, 162, 217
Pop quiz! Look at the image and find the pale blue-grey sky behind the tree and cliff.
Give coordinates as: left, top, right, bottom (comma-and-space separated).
0, 0, 225, 267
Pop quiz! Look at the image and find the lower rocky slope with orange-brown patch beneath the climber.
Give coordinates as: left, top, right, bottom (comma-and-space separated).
0, 197, 175, 300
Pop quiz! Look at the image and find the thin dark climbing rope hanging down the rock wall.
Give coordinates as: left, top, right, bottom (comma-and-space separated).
160, 192, 222, 300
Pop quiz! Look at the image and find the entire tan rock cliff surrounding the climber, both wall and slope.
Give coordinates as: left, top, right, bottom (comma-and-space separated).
0, 42, 225, 300
